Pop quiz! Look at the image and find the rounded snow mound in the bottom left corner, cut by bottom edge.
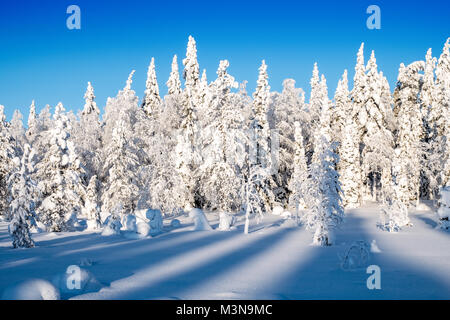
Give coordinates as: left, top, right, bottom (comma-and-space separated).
2, 279, 60, 300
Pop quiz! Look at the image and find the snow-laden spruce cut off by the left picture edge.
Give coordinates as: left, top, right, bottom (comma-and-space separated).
0, 105, 15, 220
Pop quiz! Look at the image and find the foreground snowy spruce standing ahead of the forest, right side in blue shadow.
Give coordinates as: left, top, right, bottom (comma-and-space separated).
301, 135, 344, 246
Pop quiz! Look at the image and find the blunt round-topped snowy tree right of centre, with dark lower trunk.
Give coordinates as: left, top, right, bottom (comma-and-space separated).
269, 79, 310, 207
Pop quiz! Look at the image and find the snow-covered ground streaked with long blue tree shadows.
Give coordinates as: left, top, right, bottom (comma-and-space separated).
0, 206, 450, 299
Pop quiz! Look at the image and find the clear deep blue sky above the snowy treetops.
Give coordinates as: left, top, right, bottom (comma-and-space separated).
0, 0, 450, 120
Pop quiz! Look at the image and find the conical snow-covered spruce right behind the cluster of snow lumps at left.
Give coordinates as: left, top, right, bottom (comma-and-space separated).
102, 114, 139, 218
